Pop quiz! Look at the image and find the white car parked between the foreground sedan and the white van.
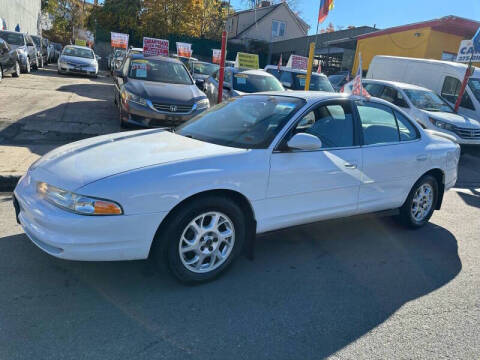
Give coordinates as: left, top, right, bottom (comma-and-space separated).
344, 79, 480, 145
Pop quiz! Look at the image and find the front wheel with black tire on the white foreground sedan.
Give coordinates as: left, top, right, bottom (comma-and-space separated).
152, 196, 247, 284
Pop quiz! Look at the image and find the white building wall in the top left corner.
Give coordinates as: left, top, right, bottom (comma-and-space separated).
0, 0, 41, 35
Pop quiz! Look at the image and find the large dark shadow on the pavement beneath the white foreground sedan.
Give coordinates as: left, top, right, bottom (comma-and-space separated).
0, 217, 462, 359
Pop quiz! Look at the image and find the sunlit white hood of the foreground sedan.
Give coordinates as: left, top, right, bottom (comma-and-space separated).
29, 129, 246, 191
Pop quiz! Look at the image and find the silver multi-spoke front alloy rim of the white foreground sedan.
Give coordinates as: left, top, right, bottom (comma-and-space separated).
178, 211, 235, 273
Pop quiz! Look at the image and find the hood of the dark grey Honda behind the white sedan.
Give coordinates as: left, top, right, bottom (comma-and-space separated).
125, 79, 205, 105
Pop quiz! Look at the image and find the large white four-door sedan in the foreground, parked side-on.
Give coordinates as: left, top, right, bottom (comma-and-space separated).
14, 92, 460, 282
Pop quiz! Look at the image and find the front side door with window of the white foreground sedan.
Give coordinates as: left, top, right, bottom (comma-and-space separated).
265, 99, 362, 228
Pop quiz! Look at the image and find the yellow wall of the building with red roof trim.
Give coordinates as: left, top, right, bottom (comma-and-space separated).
352, 27, 432, 73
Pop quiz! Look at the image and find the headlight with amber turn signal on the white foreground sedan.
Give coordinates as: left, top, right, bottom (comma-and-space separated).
37, 182, 123, 215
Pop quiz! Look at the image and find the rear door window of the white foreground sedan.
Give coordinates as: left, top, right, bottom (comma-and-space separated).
357, 101, 400, 145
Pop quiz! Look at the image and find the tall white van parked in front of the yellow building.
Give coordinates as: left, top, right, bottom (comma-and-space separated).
367, 55, 480, 120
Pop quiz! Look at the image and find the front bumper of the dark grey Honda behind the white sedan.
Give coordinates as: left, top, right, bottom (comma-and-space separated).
121, 101, 206, 127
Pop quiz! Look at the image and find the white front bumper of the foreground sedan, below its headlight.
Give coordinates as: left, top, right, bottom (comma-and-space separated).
14, 174, 166, 261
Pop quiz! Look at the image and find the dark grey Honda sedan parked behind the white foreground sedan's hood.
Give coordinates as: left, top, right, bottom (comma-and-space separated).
113, 54, 209, 127
